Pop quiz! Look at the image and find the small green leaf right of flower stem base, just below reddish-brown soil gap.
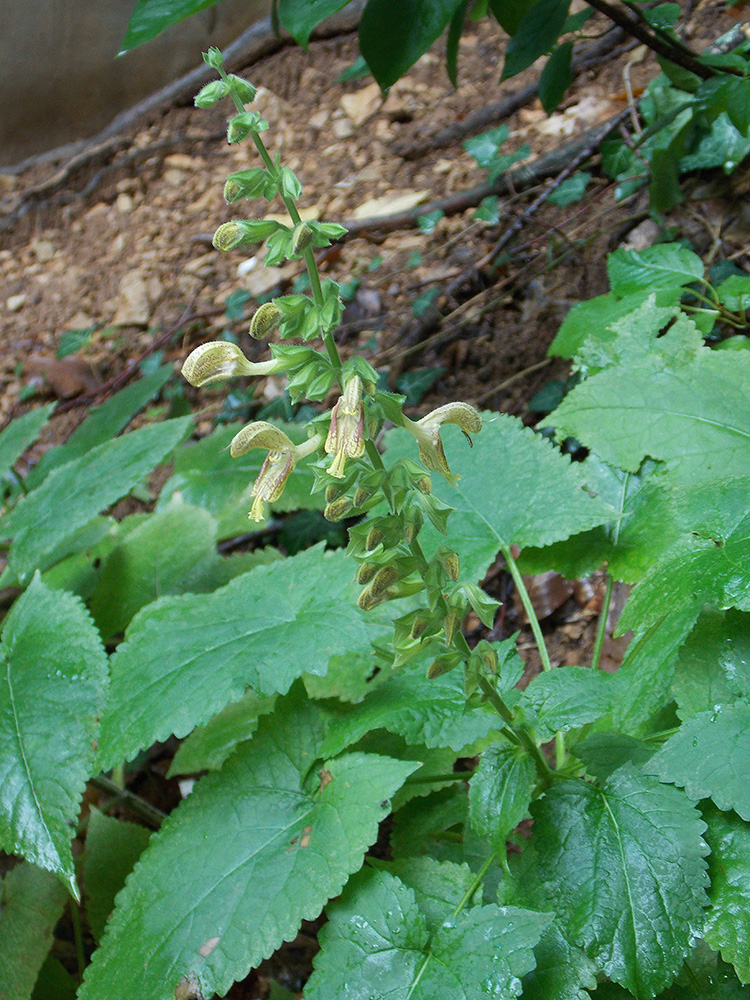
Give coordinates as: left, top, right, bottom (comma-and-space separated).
520, 667, 616, 741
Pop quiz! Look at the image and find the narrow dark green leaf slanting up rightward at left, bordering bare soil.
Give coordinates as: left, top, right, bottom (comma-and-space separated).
26, 365, 174, 488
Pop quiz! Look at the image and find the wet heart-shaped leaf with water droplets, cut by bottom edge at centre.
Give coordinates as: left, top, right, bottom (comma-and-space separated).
305, 871, 551, 1000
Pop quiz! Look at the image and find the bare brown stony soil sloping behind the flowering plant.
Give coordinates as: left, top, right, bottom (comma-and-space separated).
0, 0, 750, 1000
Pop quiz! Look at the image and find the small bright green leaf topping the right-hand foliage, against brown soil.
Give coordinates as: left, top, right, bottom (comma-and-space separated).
607, 243, 703, 295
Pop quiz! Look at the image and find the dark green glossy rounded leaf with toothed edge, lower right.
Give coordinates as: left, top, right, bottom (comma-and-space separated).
525, 764, 707, 1000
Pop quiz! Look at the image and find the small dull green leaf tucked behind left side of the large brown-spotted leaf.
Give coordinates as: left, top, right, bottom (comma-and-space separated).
83, 806, 151, 944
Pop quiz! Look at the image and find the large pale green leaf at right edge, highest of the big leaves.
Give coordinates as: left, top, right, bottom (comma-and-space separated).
549, 349, 750, 483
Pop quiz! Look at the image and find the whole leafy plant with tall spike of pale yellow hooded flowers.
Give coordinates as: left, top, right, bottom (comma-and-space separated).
0, 13, 750, 1000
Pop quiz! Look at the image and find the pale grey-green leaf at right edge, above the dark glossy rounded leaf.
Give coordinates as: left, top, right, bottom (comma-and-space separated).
645, 702, 750, 820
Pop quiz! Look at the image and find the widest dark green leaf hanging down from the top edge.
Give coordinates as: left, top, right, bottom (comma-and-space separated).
359, 0, 462, 90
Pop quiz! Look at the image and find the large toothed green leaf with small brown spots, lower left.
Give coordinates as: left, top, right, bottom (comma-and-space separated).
80, 688, 417, 1000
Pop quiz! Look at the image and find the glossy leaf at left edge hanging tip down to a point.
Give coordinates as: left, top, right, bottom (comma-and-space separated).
0, 577, 107, 898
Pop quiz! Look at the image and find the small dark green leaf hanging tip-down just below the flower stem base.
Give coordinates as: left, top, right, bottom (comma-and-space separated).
469, 743, 536, 857
